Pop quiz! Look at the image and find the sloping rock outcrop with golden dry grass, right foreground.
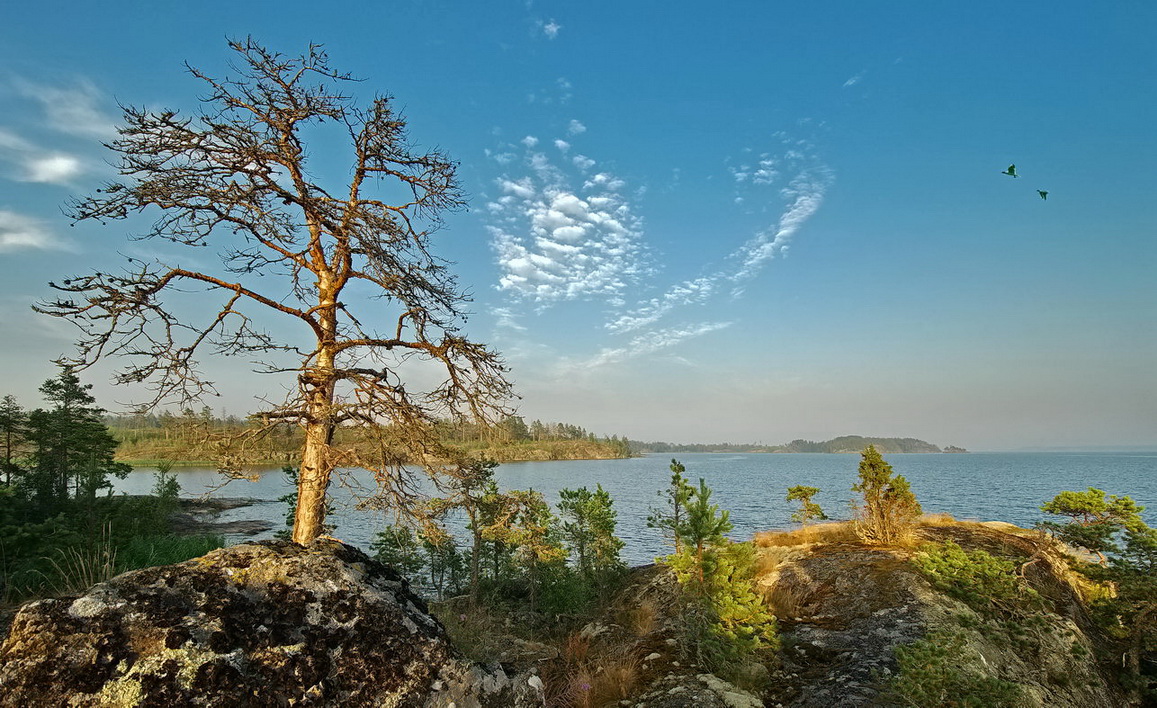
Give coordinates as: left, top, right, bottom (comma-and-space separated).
759, 523, 1130, 708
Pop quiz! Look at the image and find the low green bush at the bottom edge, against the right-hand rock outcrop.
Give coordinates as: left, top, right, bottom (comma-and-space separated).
883, 630, 1024, 708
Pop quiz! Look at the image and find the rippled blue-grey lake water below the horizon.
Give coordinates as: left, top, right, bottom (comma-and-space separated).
116, 452, 1157, 565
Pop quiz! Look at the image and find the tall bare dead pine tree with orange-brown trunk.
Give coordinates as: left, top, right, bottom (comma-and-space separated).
37, 39, 510, 544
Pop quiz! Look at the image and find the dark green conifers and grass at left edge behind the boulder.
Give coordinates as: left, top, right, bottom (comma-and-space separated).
0, 367, 223, 602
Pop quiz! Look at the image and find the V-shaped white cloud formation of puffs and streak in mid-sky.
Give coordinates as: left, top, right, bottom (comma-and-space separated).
487, 120, 832, 373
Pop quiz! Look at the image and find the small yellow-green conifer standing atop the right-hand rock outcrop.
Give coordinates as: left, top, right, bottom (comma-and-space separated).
852, 445, 922, 545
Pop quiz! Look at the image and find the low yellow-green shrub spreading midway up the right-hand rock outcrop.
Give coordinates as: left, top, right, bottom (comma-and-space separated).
912, 540, 1041, 618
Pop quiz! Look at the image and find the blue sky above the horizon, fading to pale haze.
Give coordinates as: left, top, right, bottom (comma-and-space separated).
0, 0, 1157, 449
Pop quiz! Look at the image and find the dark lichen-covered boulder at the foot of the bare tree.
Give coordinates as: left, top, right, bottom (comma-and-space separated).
0, 539, 541, 708
